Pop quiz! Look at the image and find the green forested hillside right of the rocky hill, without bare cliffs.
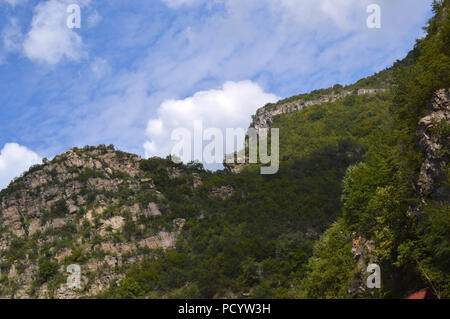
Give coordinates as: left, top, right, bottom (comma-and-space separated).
107, 1, 450, 298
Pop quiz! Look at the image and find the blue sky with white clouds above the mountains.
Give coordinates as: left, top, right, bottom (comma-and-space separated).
0, 0, 432, 189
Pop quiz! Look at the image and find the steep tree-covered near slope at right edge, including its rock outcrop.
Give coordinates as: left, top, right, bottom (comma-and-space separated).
303, 0, 450, 298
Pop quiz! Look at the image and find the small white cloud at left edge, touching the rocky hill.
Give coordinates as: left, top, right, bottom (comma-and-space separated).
0, 143, 41, 189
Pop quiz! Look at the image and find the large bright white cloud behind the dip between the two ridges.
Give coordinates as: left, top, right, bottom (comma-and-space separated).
144, 81, 278, 161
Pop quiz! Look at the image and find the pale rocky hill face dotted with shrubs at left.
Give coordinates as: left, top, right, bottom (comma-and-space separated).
0, 146, 186, 299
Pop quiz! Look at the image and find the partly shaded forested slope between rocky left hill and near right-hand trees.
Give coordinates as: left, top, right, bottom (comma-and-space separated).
103, 92, 391, 298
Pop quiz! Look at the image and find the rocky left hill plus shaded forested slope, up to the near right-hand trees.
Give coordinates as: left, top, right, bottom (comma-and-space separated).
0, 92, 389, 298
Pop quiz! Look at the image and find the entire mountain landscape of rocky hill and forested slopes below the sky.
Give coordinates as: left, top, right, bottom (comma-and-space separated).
0, 1, 450, 298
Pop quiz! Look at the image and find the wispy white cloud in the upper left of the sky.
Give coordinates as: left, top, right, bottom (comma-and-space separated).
23, 0, 89, 65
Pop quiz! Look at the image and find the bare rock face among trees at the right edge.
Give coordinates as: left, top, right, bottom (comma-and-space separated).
416, 89, 450, 200
